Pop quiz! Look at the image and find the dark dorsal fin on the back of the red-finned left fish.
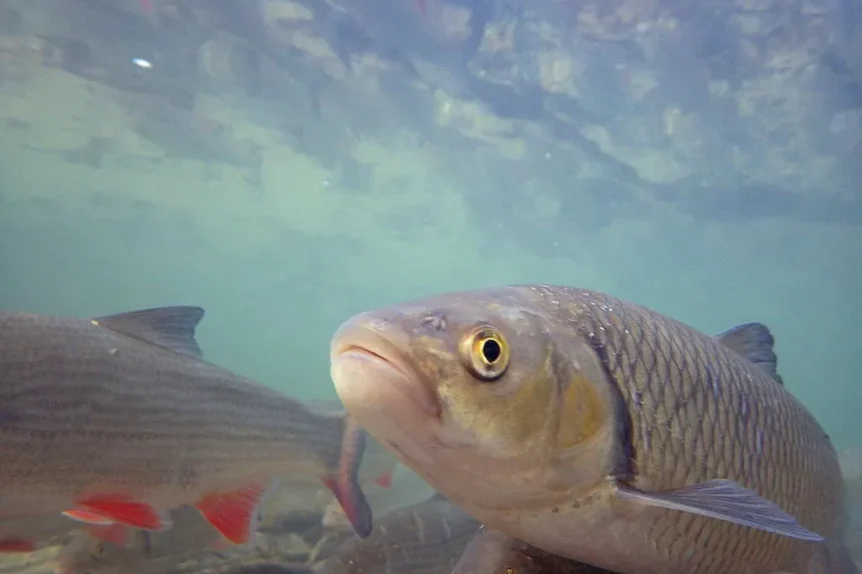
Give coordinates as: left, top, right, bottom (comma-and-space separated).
93, 307, 204, 359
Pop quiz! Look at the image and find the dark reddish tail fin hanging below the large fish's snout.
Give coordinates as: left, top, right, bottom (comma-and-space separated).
323, 415, 374, 538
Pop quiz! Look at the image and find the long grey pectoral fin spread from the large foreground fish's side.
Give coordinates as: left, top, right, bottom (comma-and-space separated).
617, 479, 823, 542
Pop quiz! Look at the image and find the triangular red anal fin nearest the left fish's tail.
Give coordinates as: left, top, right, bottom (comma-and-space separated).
195, 483, 267, 544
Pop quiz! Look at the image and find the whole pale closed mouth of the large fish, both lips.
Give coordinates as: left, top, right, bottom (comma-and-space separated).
330, 323, 442, 418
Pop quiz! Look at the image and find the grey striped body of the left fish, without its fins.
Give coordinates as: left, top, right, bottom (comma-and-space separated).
0, 313, 341, 498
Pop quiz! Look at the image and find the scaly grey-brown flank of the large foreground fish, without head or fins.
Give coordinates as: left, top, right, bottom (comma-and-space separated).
532, 286, 843, 571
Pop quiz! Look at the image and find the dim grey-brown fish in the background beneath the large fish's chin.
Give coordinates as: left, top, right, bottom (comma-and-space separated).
318, 496, 480, 574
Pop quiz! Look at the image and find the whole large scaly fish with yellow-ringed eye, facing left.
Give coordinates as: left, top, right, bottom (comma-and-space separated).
330, 285, 856, 574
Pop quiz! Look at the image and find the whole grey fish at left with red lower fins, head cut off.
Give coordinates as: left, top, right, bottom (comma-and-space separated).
0, 307, 372, 544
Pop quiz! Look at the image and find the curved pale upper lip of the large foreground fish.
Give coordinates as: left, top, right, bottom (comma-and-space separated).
330, 323, 442, 419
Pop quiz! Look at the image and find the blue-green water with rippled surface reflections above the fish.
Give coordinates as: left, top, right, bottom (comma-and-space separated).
0, 0, 862, 449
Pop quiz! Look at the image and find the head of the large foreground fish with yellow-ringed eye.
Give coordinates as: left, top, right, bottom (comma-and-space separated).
331, 288, 615, 505
